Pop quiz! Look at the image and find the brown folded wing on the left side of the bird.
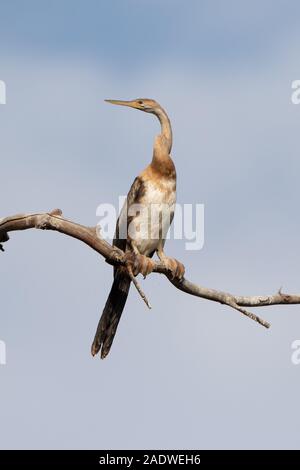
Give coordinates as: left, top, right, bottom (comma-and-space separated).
113, 176, 145, 251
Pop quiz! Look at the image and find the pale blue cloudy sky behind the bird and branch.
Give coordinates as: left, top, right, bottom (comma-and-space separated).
0, 0, 300, 449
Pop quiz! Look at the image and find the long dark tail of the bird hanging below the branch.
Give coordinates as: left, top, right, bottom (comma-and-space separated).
92, 271, 131, 359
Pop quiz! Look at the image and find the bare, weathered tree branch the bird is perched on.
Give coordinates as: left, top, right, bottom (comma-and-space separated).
0, 209, 300, 328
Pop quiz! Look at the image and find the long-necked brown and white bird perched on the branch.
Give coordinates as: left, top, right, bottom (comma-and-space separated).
91, 98, 185, 359
